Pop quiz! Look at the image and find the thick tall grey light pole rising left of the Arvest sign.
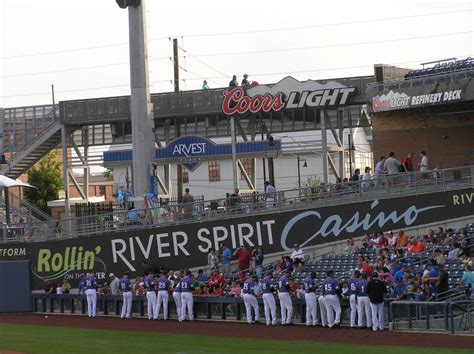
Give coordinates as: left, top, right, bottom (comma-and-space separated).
116, 0, 155, 209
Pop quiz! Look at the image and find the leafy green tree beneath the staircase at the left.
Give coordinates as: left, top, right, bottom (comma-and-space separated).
25, 151, 63, 213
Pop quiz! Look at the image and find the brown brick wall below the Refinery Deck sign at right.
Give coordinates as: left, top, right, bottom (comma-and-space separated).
372, 115, 474, 168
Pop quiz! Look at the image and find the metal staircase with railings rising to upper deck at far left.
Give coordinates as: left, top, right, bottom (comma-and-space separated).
0, 106, 61, 179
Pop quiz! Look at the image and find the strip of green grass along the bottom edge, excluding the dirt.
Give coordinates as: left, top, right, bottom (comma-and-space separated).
0, 324, 472, 354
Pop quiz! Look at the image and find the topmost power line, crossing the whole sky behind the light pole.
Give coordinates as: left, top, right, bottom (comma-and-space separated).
0, 9, 473, 60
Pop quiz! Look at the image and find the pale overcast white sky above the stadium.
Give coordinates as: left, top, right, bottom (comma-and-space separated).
0, 0, 474, 107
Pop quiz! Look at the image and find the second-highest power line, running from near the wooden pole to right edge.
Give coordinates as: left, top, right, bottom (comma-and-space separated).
189, 31, 474, 58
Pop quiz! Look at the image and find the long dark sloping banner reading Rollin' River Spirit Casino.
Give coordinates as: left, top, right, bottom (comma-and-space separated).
0, 188, 474, 288
